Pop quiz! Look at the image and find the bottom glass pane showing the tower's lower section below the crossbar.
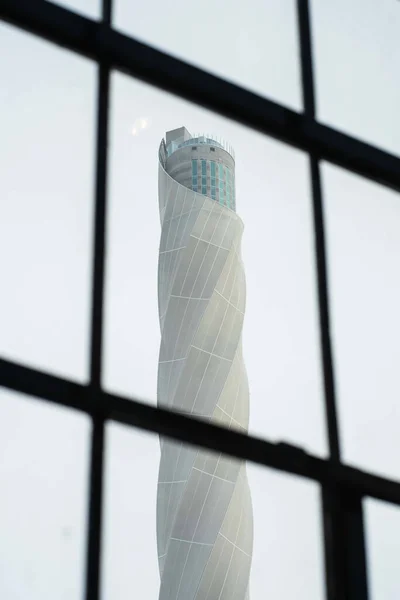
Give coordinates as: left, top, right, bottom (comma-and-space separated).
102, 424, 324, 600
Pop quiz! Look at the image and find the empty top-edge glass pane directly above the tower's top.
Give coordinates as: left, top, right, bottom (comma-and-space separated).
114, 0, 302, 110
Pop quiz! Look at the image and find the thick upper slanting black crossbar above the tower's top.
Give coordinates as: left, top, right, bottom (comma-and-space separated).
0, 0, 400, 189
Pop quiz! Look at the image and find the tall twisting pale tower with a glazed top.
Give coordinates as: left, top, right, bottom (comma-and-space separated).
157, 127, 253, 600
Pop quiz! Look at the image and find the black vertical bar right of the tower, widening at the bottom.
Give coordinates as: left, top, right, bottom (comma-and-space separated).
297, 0, 368, 600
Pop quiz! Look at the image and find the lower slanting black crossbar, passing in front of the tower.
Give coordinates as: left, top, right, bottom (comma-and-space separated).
0, 359, 400, 504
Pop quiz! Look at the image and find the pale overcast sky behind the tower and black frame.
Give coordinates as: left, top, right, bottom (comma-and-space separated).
0, 0, 400, 600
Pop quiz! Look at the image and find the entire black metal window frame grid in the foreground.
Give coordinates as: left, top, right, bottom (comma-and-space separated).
0, 0, 400, 600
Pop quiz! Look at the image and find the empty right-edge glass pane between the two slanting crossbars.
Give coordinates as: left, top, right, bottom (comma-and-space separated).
322, 164, 400, 478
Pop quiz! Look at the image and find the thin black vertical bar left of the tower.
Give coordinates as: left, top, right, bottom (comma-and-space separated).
85, 0, 112, 600
